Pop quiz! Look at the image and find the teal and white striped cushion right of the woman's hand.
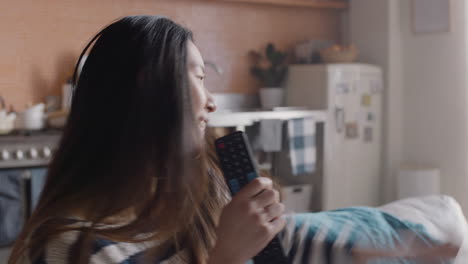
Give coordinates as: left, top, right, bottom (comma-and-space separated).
280, 207, 448, 264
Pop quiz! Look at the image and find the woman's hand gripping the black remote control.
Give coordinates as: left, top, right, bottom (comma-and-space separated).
209, 177, 286, 264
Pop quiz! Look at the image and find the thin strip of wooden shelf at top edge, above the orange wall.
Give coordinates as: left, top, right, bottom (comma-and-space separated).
211, 0, 348, 9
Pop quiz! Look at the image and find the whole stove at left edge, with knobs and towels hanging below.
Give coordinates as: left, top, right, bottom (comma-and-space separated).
0, 130, 61, 251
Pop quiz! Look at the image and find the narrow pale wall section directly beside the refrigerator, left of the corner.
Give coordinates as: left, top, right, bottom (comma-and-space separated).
350, 0, 403, 202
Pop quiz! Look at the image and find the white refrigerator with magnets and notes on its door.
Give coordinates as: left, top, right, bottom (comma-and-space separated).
286, 64, 383, 210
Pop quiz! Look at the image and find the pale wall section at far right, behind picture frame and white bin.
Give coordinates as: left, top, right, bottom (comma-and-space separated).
400, 0, 468, 212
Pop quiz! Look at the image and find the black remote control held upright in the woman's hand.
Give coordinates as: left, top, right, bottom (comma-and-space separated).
215, 131, 288, 264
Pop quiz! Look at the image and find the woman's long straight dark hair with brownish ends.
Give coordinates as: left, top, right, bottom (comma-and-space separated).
9, 16, 229, 264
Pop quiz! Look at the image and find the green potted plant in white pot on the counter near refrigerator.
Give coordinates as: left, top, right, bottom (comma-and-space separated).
250, 43, 288, 108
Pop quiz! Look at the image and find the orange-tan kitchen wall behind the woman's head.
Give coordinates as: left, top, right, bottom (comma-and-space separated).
0, 0, 339, 110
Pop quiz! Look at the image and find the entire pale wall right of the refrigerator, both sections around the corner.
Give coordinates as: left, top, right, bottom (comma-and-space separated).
345, 0, 468, 212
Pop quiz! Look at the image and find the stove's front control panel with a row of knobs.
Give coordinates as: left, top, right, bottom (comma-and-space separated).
0, 130, 61, 169
